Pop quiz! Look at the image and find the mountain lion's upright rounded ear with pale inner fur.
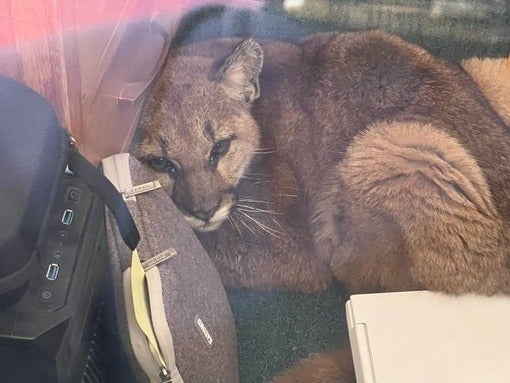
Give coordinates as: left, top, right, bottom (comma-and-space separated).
216, 39, 264, 103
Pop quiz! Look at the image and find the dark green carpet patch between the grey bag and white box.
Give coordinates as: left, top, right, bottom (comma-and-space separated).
228, 287, 348, 383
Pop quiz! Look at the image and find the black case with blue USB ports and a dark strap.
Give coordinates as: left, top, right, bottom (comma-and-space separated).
0, 77, 139, 383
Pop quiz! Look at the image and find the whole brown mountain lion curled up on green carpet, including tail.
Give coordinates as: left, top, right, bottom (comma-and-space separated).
133, 32, 510, 382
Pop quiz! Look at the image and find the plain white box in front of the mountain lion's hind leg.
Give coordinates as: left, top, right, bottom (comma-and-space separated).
346, 291, 510, 383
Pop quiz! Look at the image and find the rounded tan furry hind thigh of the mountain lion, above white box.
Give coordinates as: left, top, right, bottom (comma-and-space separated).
331, 123, 510, 294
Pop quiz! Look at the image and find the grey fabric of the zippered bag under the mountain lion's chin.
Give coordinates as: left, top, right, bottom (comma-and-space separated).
107, 157, 239, 383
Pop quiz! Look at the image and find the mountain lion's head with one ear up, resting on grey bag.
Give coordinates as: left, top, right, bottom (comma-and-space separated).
133, 40, 263, 231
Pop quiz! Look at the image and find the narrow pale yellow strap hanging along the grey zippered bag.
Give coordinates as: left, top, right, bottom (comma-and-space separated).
131, 249, 166, 368
